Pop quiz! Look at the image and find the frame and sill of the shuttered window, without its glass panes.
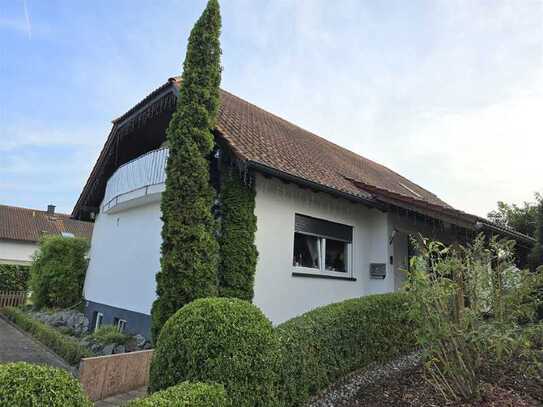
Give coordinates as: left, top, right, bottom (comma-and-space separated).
291, 217, 356, 281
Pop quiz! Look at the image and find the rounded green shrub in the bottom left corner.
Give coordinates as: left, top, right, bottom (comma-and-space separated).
0, 362, 92, 407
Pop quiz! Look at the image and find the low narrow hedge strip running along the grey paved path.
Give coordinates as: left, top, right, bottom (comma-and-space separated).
2, 308, 92, 365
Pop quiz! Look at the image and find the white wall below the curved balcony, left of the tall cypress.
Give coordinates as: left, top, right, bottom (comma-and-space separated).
84, 199, 162, 314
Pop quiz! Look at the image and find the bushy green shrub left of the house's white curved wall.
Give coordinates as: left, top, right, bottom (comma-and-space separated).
30, 236, 89, 308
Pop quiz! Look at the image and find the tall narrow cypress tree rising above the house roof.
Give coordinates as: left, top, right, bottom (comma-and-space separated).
151, 0, 221, 340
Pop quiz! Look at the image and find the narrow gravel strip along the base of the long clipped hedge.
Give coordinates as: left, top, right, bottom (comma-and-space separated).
308, 352, 422, 407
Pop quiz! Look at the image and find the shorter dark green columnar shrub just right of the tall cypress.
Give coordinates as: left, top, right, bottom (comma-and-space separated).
219, 170, 258, 301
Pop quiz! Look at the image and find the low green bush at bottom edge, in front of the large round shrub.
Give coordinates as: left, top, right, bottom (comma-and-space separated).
126, 382, 228, 407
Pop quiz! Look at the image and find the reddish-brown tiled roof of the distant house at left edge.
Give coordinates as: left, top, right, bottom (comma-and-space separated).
0, 205, 93, 242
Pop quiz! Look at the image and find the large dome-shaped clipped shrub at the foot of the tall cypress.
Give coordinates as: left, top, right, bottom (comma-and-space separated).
149, 298, 278, 407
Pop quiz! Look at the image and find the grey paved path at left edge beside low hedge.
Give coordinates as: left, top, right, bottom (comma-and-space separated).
0, 317, 73, 372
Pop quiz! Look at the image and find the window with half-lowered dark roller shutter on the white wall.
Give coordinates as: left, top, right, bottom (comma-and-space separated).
292, 214, 353, 276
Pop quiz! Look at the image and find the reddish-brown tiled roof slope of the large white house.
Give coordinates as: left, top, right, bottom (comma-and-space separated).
215, 85, 451, 208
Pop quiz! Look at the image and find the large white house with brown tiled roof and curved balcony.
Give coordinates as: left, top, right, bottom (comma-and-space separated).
72, 78, 533, 335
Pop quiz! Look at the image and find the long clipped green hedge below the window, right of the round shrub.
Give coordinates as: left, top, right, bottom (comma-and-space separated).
276, 293, 416, 406
